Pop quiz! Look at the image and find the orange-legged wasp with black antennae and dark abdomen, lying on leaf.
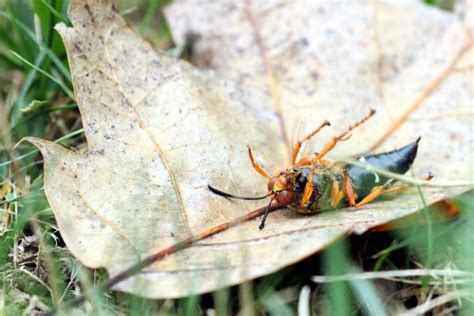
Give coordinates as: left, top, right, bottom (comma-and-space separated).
208, 109, 420, 229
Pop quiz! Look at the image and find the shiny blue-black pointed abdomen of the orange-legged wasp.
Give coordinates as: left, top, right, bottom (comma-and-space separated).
346, 138, 420, 197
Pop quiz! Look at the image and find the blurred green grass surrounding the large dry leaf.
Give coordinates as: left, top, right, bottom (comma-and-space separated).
0, 0, 474, 315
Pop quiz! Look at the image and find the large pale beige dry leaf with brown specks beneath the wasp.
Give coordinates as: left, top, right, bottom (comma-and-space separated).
28, 0, 473, 298
